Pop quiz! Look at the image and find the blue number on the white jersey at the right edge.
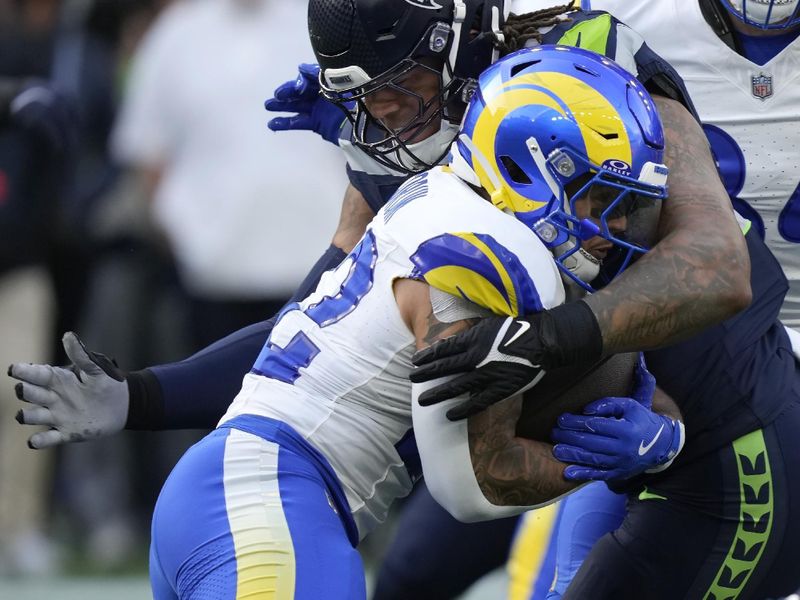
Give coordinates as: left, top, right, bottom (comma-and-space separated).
703, 125, 800, 244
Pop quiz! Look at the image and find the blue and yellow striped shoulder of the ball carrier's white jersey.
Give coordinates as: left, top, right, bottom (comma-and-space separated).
411, 232, 552, 316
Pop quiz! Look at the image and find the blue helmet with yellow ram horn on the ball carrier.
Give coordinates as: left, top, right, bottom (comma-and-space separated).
451, 46, 668, 291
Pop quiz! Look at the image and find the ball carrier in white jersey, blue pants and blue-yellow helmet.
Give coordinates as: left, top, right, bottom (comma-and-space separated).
144, 46, 683, 600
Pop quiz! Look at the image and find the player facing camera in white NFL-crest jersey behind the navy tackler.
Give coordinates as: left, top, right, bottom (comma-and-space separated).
504, 0, 800, 598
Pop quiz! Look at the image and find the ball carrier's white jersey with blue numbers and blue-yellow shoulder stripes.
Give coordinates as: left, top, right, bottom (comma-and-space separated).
221, 167, 564, 538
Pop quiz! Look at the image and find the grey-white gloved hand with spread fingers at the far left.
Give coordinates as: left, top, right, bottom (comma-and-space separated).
8, 332, 129, 449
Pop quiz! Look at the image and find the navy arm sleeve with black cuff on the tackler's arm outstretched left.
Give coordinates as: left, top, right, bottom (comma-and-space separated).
125, 246, 346, 430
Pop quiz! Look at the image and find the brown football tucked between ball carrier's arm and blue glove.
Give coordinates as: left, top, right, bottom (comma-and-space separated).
517, 352, 637, 442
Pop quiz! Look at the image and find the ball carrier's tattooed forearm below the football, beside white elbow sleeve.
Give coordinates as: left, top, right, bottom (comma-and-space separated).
468, 397, 575, 506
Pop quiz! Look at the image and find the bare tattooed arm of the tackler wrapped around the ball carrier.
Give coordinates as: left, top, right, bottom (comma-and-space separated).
586, 97, 750, 354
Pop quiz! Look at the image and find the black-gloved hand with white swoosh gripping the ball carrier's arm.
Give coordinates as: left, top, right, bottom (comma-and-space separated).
411, 315, 544, 421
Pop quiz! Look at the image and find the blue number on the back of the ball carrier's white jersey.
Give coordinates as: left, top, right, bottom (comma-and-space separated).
253, 230, 378, 383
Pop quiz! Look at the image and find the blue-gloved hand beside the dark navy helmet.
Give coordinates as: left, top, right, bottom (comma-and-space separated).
264, 63, 346, 146
